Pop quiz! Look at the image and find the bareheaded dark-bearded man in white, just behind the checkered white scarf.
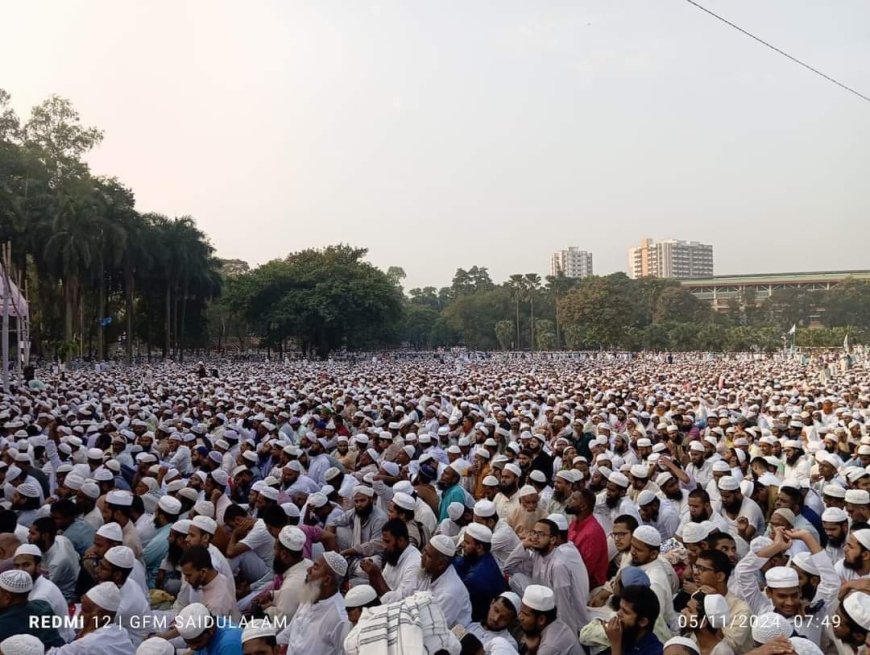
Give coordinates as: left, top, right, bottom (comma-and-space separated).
360, 518, 420, 605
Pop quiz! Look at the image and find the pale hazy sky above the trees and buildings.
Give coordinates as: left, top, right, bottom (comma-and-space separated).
0, 0, 870, 288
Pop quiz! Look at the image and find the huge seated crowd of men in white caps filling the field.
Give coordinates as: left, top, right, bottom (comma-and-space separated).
0, 354, 870, 655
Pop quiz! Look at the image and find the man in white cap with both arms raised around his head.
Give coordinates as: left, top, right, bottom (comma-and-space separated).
734, 528, 840, 643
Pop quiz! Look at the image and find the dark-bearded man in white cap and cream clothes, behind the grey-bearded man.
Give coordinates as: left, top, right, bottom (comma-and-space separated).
258, 525, 312, 625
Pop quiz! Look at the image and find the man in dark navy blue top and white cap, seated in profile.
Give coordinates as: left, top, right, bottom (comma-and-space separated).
453, 523, 507, 621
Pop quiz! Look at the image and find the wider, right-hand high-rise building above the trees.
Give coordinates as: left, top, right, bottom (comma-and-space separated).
628, 239, 713, 280
